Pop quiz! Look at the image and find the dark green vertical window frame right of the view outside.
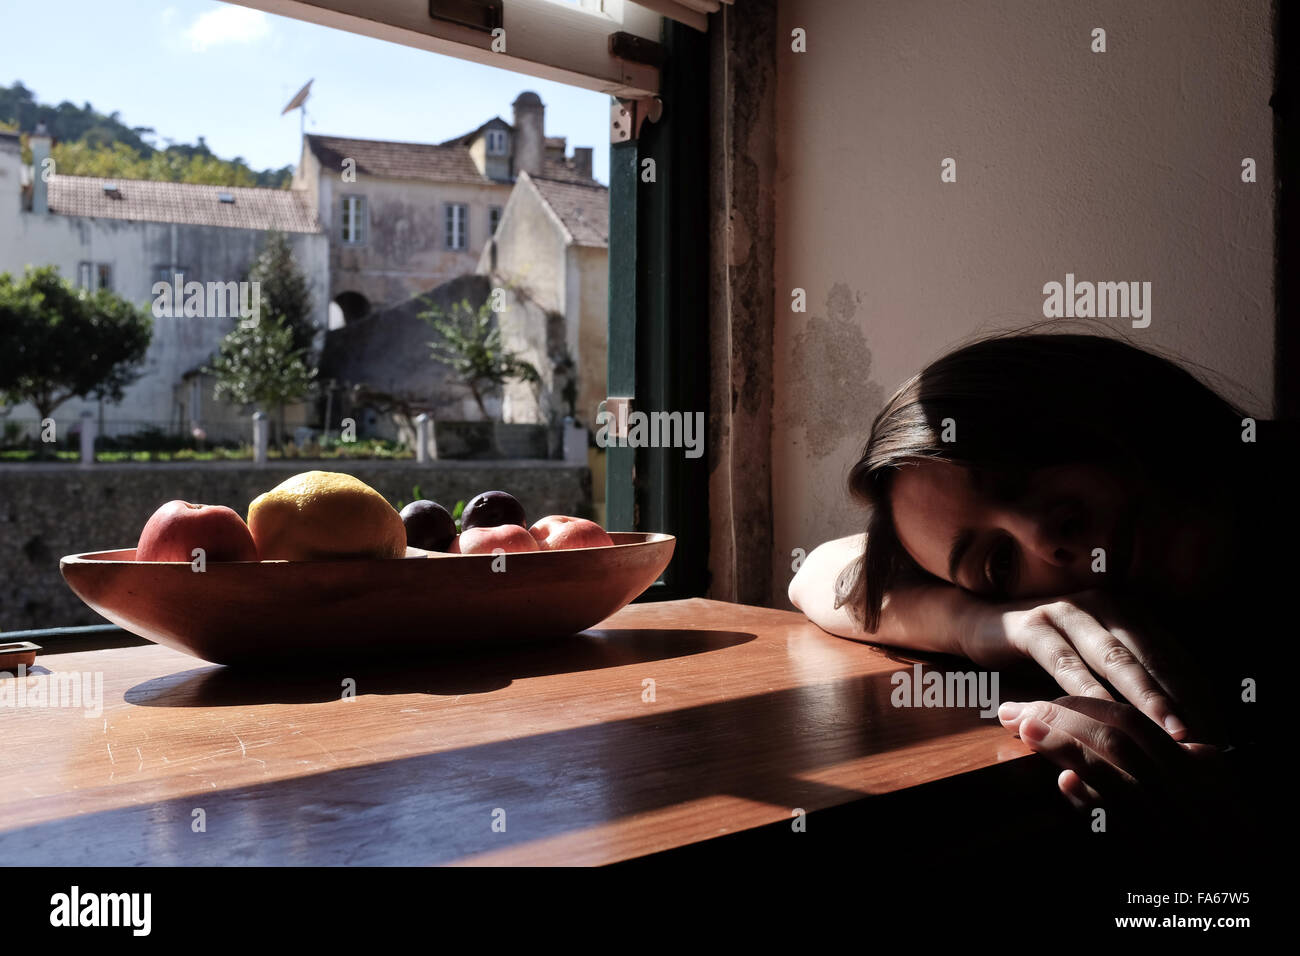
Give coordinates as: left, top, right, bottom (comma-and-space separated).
606, 21, 711, 601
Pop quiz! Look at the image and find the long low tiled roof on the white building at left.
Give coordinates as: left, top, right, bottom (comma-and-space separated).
48, 176, 321, 233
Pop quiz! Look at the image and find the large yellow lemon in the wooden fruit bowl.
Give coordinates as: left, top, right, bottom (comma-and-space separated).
248, 471, 406, 561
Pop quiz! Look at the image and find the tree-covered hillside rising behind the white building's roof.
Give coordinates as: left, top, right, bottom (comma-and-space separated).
0, 82, 294, 189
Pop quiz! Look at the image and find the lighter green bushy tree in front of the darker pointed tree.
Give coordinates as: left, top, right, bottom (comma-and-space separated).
210, 316, 316, 447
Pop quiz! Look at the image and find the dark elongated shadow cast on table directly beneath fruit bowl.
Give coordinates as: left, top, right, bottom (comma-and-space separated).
125, 628, 754, 708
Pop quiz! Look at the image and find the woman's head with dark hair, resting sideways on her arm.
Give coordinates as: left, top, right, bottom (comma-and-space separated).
846, 327, 1242, 631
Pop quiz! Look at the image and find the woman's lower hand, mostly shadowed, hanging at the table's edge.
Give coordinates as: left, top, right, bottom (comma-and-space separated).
997, 697, 1225, 809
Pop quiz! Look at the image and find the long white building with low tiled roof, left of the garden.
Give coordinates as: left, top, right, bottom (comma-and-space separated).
0, 133, 329, 440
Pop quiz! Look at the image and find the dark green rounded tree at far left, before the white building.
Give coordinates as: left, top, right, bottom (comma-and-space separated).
0, 265, 153, 419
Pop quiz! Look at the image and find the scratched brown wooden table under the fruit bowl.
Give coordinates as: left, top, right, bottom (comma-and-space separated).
0, 600, 1028, 865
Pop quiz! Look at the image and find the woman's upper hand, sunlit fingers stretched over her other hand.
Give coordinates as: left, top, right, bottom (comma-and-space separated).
962, 591, 1199, 740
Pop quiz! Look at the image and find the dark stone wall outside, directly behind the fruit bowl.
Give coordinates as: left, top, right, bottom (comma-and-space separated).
0, 460, 592, 631
